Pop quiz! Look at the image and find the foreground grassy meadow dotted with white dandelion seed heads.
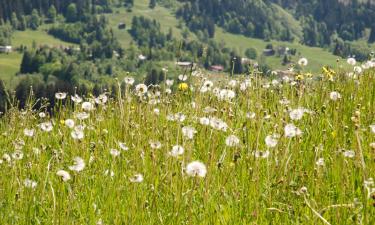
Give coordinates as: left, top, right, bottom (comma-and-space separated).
0, 61, 375, 224
